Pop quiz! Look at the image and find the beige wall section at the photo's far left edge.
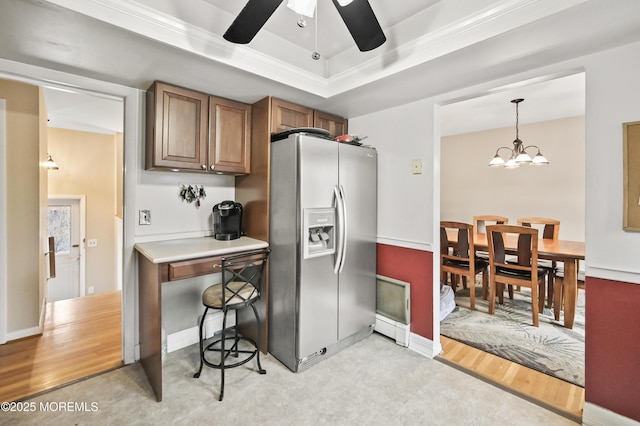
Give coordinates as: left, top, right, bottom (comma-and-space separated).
0, 80, 44, 334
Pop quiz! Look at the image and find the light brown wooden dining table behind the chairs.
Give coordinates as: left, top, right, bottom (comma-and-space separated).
447, 231, 584, 329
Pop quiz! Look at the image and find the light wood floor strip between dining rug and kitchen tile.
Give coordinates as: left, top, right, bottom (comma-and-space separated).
438, 336, 584, 423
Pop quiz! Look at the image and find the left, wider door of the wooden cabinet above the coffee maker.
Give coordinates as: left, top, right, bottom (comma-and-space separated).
146, 82, 209, 170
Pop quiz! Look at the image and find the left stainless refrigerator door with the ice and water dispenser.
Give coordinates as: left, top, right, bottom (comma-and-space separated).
297, 136, 338, 360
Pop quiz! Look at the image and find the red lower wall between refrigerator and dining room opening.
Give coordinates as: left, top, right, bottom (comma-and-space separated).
378, 244, 433, 340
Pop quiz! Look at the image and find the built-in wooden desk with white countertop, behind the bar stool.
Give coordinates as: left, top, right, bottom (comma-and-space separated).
135, 237, 268, 401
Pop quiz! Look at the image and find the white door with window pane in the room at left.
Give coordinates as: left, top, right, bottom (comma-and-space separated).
47, 198, 84, 302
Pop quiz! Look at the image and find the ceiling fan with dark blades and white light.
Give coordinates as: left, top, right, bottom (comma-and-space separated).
223, 0, 387, 52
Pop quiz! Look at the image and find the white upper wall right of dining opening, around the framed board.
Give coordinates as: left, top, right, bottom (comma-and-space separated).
585, 43, 640, 284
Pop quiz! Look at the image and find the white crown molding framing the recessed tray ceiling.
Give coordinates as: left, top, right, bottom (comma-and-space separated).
46, 0, 586, 98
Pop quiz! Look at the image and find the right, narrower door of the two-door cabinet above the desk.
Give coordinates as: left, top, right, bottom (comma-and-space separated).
209, 96, 251, 174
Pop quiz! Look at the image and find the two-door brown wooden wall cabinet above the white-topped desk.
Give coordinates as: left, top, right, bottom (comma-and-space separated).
145, 82, 251, 175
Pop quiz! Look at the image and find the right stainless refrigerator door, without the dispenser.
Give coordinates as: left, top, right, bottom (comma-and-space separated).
338, 144, 378, 340
